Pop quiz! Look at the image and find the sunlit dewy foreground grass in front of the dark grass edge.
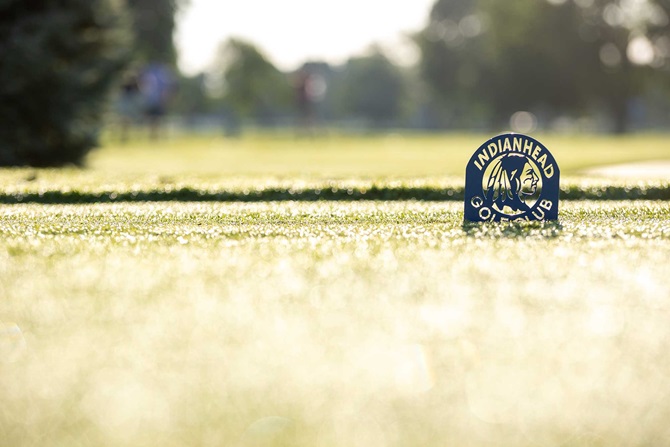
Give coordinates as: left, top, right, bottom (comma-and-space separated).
0, 201, 670, 447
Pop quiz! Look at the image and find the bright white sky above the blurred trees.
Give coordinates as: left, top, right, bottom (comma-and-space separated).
176, 0, 435, 74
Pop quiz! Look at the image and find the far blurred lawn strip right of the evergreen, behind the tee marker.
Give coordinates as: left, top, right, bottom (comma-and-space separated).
90, 134, 670, 179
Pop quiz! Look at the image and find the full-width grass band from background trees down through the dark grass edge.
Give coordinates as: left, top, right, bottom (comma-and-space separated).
0, 134, 670, 203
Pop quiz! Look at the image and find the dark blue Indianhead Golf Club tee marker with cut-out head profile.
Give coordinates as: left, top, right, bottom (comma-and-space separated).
465, 133, 560, 222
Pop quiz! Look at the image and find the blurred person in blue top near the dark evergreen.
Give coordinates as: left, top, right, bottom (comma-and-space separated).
139, 63, 174, 140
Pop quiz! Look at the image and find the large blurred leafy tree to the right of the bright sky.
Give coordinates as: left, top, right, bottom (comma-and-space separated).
416, 0, 670, 132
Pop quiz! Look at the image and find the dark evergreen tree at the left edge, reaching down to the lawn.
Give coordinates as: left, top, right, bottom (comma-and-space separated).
0, 0, 126, 167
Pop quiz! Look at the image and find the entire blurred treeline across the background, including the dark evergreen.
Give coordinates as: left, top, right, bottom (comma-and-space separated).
0, 0, 670, 166
